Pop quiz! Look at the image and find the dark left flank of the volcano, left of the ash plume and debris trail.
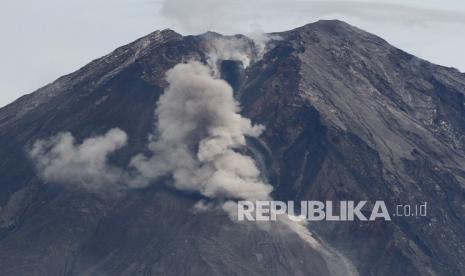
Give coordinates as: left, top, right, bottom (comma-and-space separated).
0, 27, 334, 275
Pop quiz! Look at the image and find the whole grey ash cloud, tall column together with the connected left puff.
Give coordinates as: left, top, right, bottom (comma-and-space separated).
29, 62, 272, 200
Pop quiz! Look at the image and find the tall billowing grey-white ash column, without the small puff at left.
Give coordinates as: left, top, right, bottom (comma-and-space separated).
131, 62, 272, 200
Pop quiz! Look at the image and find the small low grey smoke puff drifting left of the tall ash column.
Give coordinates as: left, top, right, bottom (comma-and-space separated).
29, 128, 127, 190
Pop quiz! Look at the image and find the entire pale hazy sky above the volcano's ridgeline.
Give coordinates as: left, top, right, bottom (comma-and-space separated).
0, 0, 465, 106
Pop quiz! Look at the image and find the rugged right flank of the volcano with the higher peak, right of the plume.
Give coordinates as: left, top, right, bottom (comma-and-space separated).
242, 21, 465, 275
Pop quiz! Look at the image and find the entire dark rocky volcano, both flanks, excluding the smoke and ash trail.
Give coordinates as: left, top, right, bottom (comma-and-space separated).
0, 21, 465, 275
